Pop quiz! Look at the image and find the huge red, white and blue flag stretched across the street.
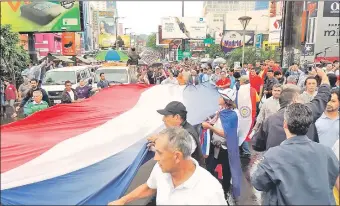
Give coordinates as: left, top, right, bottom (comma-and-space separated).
1, 85, 219, 205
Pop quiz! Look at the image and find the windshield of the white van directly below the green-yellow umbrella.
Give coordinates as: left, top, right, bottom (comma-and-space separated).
95, 69, 128, 83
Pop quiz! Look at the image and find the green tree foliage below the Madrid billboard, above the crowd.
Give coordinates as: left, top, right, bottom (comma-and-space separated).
227, 47, 280, 65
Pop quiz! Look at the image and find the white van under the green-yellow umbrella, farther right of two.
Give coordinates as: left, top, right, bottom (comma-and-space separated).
92, 66, 137, 88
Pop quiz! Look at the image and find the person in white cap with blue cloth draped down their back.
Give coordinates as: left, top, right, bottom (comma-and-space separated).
202, 89, 242, 201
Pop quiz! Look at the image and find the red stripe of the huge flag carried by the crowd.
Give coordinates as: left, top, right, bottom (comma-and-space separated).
1, 85, 149, 173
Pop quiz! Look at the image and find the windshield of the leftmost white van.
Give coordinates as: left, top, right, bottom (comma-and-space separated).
43, 71, 77, 85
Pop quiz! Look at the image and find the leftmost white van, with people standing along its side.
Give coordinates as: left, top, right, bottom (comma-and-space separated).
42, 66, 94, 104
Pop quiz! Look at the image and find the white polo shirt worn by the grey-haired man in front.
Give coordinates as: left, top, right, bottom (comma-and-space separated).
147, 158, 227, 205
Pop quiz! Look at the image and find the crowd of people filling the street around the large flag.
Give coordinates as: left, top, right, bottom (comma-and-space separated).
1, 54, 340, 205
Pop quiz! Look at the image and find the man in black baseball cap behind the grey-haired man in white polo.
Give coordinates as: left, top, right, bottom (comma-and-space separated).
153, 101, 205, 166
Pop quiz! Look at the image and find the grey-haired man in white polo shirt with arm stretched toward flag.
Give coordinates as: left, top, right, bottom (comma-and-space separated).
109, 127, 227, 205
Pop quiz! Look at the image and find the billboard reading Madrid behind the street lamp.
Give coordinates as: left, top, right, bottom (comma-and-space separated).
221, 31, 254, 53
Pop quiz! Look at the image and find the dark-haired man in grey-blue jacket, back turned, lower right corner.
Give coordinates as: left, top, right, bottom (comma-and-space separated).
251, 103, 339, 205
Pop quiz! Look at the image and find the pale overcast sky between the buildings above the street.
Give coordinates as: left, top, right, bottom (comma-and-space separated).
117, 1, 203, 34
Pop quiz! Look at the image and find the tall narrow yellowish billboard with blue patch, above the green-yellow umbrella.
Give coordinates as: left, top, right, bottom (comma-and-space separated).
98, 11, 116, 48
